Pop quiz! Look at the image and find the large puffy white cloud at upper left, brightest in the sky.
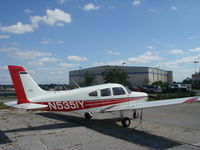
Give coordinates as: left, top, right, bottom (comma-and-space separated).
31, 9, 72, 27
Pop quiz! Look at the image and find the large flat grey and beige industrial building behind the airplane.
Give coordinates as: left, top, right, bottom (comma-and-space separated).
69, 66, 173, 86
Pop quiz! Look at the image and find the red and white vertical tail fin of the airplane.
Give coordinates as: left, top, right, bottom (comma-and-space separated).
8, 65, 45, 104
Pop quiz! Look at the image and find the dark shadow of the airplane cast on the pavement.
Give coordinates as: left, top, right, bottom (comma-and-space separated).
4, 112, 182, 149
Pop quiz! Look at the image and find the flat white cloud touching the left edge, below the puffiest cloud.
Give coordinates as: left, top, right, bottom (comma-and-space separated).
0, 22, 34, 34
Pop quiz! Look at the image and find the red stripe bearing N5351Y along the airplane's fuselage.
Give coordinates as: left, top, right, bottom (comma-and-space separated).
37, 97, 145, 111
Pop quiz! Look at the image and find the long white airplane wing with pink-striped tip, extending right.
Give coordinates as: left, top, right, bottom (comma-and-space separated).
105, 97, 200, 112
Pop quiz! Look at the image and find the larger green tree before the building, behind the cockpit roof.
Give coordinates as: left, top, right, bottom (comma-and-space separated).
103, 67, 130, 86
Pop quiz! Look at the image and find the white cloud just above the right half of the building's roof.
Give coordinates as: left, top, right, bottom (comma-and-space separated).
127, 51, 162, 64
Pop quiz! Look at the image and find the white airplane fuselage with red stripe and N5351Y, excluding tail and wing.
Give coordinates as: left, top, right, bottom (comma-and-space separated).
29, 83, 148, 112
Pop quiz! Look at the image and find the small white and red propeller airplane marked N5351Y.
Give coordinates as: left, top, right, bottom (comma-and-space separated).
5, 65, 200, 127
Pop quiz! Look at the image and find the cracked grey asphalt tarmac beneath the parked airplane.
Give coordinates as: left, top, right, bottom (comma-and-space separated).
0, 99, 200, 150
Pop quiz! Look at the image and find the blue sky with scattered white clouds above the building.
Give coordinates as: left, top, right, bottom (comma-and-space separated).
0, 0, 200, 84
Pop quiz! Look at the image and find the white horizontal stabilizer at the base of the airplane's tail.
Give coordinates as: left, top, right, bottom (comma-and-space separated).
4, 101, 48, 109
